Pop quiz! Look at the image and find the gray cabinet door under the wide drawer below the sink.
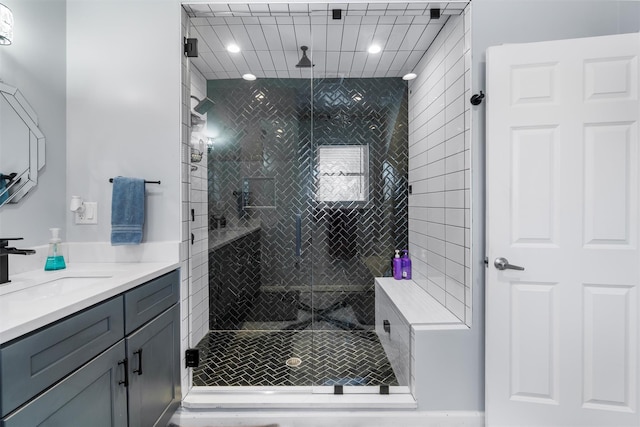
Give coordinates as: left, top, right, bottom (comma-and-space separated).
1, 340, 127, 427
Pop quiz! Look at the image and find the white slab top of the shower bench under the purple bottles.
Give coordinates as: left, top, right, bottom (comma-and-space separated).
376, 277, 462, 325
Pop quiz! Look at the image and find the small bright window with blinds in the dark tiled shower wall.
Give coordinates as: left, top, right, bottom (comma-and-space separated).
316, 145, 369, 202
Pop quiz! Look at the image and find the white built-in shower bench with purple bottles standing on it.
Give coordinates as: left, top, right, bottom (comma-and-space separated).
375, 277, 469, 410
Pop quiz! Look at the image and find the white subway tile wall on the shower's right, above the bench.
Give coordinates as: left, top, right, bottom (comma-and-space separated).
409, 8, 471, 325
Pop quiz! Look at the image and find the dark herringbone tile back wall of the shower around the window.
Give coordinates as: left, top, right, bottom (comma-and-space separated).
207, 78, 408, 330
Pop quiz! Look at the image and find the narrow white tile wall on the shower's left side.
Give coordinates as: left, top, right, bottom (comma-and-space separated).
180, 10, 209, 397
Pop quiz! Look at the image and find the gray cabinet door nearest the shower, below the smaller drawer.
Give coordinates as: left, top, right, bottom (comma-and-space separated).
126, 305, 180, 427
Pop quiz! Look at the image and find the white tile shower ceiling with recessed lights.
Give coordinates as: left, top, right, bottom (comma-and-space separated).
183, 1, 468, 80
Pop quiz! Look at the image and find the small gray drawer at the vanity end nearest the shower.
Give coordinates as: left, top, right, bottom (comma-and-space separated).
124, 270, 180, 334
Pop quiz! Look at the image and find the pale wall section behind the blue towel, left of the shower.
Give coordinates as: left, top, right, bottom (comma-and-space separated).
67, 0, 182, 246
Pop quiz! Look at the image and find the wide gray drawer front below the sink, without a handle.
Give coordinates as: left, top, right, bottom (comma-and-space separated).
0, 297, 124, 416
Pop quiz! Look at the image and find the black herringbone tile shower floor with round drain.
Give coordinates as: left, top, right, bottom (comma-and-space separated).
193, 331, 398, 387
